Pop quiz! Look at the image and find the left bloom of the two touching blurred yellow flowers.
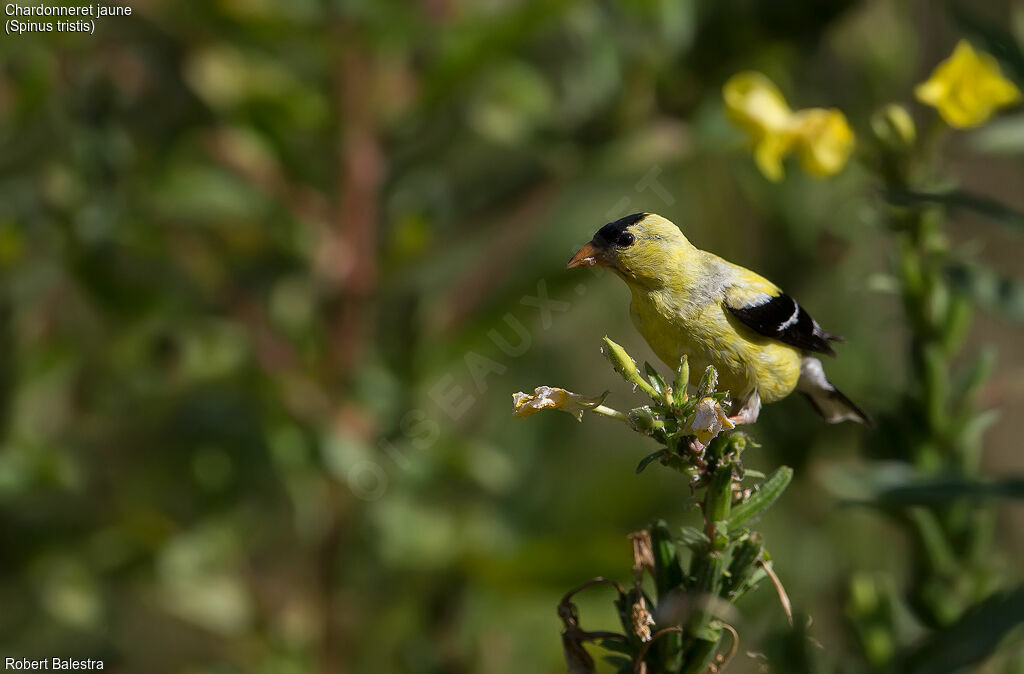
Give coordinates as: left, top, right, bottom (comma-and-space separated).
722, 71, 796, 181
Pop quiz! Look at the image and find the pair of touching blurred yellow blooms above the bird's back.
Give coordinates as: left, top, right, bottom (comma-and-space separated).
722, 72, 854, 181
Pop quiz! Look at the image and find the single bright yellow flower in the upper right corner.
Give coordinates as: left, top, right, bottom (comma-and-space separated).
914, 40, 1021, 129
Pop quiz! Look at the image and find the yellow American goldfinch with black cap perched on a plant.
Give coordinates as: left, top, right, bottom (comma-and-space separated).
567, 213, 870, 424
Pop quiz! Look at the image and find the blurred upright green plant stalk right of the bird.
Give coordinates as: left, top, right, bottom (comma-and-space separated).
848, 99, 998, 672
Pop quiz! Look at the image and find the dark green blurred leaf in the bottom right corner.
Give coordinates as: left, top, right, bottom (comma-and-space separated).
899, 586, 1024, 674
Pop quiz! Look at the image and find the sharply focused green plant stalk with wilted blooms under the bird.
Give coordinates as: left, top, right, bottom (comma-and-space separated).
513, 337, 793, 674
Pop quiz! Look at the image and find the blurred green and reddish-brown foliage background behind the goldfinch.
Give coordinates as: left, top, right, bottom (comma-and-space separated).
0, 0, 1024, 674
